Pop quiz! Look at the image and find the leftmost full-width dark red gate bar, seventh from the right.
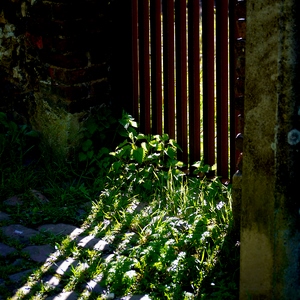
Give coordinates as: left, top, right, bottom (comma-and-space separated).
139, 0, 151, 134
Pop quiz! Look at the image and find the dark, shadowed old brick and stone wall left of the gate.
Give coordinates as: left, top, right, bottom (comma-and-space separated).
0, 0, 111, 156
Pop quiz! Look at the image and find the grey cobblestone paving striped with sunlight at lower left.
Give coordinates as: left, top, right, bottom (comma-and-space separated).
0, 212, 150, 300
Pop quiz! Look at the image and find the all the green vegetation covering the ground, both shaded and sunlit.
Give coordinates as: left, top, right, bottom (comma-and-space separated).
0, 110, 238, 299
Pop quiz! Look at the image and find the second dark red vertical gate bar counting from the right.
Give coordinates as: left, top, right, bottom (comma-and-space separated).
202, 0, 215, 166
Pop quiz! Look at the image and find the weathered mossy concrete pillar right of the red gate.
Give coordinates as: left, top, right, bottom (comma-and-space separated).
240, 0, 300, 300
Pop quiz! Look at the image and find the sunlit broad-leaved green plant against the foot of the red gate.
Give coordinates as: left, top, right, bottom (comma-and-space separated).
108, 120, 184, 190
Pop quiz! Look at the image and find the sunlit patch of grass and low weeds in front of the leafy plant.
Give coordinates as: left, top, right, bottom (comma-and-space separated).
89, 172, 237, 299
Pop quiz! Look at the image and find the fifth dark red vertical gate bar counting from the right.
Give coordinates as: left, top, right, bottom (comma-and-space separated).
162, 0, 175, 139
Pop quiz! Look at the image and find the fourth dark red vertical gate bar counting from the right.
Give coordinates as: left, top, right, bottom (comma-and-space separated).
175, 0, 188, 163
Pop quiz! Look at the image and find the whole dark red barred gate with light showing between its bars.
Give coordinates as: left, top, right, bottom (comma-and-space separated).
112, 0, 245, 181
